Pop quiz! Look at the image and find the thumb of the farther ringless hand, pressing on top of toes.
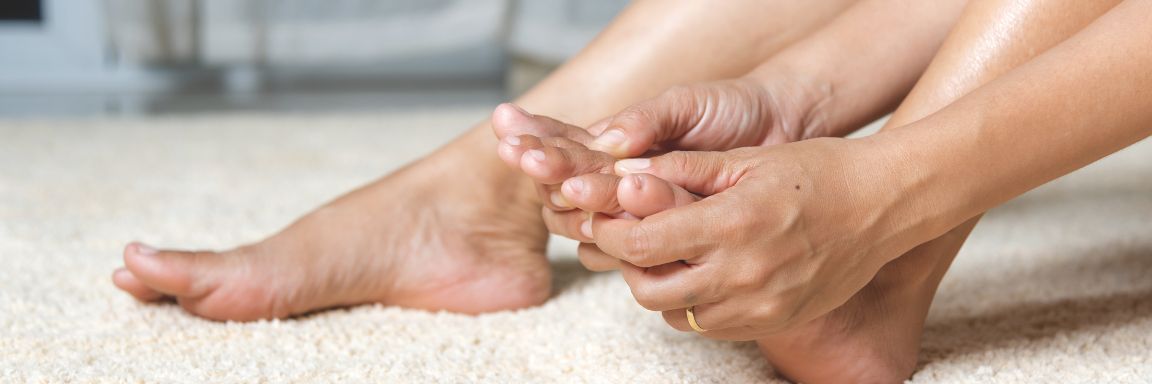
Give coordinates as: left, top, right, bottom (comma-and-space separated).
589, 86, 711, 158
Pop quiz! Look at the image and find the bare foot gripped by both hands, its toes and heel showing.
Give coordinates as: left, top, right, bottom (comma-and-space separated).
502, 129, 971, 383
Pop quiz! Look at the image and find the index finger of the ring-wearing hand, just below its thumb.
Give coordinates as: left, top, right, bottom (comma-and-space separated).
592, 196, 723, 266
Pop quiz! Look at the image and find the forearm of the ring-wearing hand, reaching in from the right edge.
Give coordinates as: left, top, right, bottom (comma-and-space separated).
872, 1, 1152, 251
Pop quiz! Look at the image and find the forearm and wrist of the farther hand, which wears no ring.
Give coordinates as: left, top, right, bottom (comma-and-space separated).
749, 0, 967, 137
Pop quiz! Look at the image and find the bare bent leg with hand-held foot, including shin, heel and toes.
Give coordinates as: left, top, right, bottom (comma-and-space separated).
483, 0, 1112, 383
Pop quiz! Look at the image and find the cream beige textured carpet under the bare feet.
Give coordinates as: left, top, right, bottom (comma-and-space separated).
0, 110, 1152, 383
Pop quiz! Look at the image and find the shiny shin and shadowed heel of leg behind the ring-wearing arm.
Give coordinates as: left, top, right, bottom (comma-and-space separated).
759, 0, 1119, 382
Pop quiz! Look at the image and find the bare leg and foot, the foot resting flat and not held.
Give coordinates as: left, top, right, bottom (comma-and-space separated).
113, 0, 848, 321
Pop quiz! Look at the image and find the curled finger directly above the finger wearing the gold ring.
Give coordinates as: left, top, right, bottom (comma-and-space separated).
620, 257, 725, 311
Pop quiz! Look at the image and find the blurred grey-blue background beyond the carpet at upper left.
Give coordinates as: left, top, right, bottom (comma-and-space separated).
0, 0, 627, 118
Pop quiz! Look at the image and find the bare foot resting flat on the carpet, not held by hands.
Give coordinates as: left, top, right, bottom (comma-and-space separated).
113, 129, 551, 321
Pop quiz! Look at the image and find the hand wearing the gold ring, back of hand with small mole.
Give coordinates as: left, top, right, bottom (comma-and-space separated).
592, 138, 932, 340
